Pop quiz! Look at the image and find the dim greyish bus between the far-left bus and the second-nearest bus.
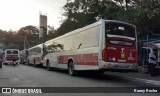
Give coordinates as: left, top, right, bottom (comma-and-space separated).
20, 49, 28, 64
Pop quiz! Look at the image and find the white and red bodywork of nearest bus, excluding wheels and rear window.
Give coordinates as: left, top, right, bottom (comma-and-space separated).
43, 20, 137, 71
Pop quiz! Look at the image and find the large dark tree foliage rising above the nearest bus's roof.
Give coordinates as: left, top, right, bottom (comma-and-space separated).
57, 0, 160, 36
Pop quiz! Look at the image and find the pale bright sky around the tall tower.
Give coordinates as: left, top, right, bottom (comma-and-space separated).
0, 0, 67, 31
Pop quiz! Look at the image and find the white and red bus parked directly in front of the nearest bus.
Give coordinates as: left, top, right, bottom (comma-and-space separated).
27, 44, 43, 67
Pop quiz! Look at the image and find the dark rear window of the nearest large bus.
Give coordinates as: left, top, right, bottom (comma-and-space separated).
105, 22, 136, 46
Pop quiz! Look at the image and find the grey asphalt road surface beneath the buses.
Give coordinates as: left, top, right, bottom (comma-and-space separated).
0, 65, 159, 96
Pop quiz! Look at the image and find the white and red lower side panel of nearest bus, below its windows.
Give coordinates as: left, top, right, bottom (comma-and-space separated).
43, 47, 98, 70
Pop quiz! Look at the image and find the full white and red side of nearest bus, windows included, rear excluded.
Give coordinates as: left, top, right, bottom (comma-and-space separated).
43, 22, 100, 70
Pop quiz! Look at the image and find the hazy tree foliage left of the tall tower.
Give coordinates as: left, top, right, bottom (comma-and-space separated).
0, 25, 40, 50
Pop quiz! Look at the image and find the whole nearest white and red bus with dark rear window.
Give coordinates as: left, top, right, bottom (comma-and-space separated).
43, 19, 137, 75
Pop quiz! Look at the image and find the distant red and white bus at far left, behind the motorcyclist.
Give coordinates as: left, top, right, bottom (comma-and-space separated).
2, 49, 20, 65
